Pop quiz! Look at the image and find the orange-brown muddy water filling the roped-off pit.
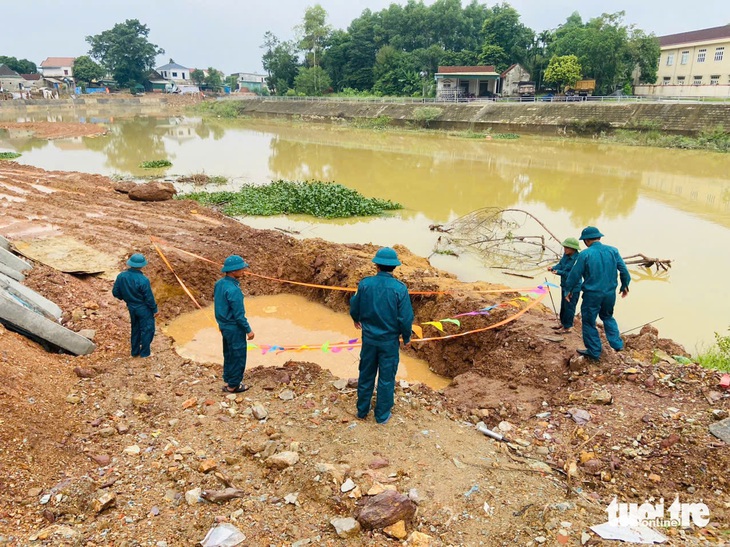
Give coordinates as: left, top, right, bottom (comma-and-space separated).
165, 294, 451, 389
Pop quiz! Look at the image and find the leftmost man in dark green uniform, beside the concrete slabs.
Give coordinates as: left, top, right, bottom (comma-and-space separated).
112, 253, 157, 357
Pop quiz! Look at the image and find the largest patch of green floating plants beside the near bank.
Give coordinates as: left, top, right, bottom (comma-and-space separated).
178, 180, 403, 218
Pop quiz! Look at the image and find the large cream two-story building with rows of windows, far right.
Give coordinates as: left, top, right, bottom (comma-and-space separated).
634, 25, 730, 97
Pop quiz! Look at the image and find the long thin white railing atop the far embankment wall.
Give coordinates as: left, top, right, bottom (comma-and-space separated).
218, 95, 730, 105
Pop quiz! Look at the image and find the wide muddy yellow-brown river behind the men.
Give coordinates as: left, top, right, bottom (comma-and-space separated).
0, 116, 730, 352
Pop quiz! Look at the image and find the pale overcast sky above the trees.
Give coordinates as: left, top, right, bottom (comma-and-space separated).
0, 0, 730, 74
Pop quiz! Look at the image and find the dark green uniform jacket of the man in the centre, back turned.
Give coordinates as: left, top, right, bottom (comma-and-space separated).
350, 272, 413, 344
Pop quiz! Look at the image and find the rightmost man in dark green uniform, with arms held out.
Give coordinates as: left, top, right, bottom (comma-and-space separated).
566, 226, 631, 359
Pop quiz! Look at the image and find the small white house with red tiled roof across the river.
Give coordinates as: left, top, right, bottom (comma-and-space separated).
434, 65, 500, 101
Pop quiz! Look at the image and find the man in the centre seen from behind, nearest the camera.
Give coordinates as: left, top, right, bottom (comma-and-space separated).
350, 247, 413, 424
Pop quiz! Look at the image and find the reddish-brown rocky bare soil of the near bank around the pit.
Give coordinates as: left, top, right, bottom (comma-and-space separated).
0, 127, 730, 547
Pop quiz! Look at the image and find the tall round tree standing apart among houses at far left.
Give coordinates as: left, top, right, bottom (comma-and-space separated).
86, 19, 165, 86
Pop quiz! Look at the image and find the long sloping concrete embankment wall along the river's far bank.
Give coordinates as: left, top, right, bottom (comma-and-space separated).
236, 99, 730, 134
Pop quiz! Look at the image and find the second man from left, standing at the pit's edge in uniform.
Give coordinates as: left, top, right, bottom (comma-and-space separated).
213, 255, 254, 393
